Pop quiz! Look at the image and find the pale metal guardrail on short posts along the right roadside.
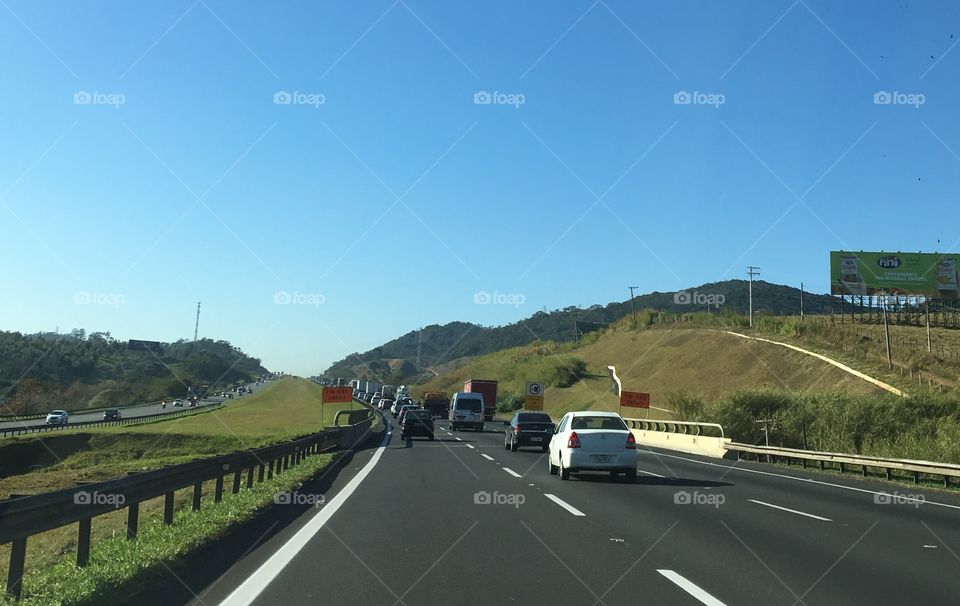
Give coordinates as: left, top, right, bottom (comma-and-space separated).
726, 442, 960, 487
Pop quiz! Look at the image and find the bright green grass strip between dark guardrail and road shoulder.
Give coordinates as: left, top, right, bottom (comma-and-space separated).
0, 454, 334, 606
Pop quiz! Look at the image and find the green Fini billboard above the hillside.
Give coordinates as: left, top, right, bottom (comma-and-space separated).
830, 251, 960, 299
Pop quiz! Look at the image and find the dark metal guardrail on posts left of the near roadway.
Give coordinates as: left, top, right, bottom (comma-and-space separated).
0, 417, 380, 600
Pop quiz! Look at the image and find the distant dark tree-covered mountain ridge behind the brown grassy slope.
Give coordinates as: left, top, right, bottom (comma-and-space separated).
324, 280, 832, 383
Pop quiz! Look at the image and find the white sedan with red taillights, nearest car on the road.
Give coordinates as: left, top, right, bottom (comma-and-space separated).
547, 410, 637, 482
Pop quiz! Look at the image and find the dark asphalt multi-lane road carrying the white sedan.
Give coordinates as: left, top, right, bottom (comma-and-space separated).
176, 414, 960, 606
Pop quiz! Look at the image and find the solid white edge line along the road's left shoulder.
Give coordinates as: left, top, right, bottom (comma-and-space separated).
220, 422, 393, 606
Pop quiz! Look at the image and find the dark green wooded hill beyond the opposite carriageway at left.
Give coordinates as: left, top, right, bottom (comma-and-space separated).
0, 329, 267, 414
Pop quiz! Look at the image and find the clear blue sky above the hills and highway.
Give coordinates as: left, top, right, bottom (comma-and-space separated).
0, 0, 960, 374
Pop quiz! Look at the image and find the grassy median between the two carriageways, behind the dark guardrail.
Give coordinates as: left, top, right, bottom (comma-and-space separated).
0, 377, 358, 604
